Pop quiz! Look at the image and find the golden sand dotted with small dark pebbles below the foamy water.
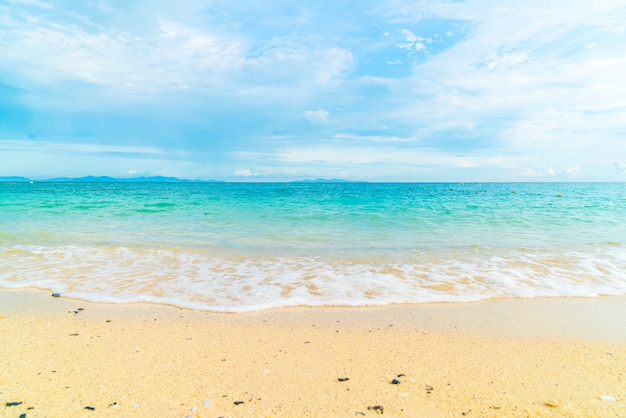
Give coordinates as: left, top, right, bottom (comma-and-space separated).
0, 290, 626, 418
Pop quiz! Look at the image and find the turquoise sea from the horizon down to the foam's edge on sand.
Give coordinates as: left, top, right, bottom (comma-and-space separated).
0, 182, 626, 312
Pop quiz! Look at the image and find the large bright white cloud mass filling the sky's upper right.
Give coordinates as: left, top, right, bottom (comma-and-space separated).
370, 1, 626, 176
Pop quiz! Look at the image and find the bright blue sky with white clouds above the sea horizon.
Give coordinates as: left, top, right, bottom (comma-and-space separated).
0, 0, 626, 181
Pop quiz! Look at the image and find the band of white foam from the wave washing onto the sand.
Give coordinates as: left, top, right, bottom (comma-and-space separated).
0, 244, 626, 312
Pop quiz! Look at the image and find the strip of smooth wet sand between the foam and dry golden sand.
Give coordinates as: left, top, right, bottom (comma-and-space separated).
0, 287, 626, 343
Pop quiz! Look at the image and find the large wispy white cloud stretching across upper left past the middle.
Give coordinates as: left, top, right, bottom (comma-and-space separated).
0, 1, 356, 106
